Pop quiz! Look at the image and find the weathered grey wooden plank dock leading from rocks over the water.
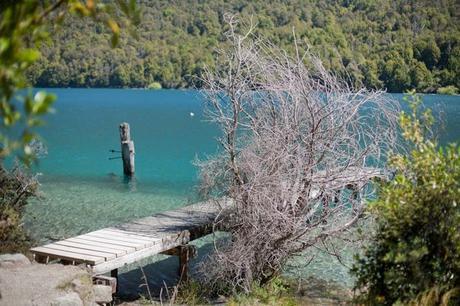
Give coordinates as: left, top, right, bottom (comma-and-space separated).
31, 200, 230, 275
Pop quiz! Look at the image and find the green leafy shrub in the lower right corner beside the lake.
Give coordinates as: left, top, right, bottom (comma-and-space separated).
352, 96, 460, 305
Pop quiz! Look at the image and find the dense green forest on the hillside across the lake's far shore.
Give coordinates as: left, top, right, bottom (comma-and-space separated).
29, 0, 460, 92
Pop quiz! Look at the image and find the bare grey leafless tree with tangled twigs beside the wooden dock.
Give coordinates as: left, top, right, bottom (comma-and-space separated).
199, 16, 398, 291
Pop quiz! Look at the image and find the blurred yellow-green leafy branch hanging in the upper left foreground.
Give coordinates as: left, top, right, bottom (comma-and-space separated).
0, 0, 140, 162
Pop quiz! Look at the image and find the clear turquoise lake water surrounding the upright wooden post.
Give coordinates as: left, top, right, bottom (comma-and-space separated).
25, 89, 460, 298
